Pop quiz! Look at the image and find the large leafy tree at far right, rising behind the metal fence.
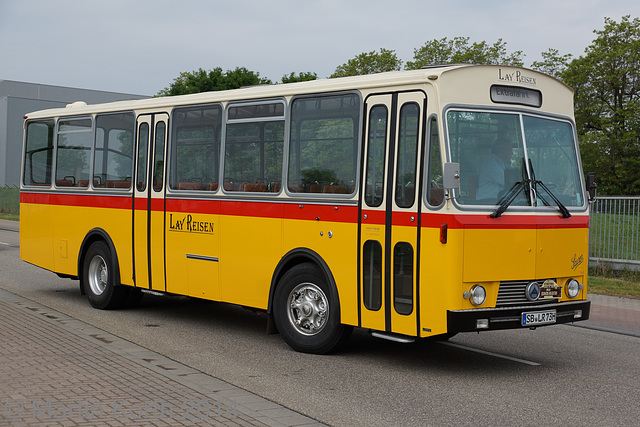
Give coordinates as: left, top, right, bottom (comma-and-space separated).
560, 15, 640, 195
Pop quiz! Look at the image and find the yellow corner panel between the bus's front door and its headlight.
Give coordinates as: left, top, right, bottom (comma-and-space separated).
420, 226, 464, 337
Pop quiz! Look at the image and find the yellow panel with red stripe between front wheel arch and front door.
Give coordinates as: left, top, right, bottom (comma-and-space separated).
283, 210, 358, 325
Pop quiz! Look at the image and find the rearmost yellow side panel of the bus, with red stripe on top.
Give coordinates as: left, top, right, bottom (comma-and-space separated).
20, 197, 54, 271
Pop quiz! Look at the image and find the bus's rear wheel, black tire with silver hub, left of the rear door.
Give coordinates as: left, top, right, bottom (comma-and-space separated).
82, 241, 131, 310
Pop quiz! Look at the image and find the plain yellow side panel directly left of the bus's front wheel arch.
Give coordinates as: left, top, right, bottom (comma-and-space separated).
220, 213, 282, 310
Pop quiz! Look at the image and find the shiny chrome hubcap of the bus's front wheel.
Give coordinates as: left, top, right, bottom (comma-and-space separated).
287, 283, 329, 335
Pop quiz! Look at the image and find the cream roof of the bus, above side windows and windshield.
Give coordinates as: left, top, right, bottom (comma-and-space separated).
26, 64, 573, 119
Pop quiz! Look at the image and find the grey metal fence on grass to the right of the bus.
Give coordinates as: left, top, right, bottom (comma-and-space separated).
589, 196, 640, 270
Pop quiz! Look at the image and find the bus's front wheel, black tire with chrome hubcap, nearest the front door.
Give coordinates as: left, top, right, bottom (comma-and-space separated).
273, 263, 353, 354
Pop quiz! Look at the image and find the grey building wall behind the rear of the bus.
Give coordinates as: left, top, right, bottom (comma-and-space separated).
0, 80, 149, 187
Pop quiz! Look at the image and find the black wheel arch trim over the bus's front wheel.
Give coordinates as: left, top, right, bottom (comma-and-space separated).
267, 248, 342, 320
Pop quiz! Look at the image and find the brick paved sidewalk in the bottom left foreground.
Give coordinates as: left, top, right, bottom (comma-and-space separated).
0, 289, 321, 426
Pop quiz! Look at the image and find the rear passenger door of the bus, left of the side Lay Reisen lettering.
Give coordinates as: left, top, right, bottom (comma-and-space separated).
133, 113, 169, 291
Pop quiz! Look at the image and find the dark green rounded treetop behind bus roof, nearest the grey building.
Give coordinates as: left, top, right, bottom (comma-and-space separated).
157, 67, 271, 96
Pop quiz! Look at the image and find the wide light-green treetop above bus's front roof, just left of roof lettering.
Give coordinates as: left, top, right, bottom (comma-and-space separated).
406, 37, 524, 70
